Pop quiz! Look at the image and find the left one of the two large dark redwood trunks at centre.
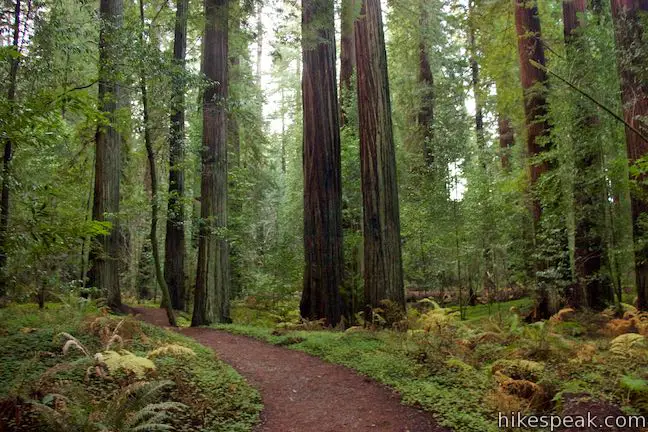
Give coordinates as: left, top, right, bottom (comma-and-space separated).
299, 0, 344, 326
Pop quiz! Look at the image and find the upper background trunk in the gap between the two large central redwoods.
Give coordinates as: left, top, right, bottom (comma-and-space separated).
340, 0, 357, 127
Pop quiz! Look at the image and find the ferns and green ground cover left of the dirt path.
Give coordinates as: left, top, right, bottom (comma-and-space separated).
0, 304, 261, 432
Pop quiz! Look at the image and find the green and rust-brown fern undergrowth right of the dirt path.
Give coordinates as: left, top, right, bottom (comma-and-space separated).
217, 299, 648, 432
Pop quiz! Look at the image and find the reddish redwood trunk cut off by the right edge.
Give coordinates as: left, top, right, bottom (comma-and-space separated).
612, 0, 648, 310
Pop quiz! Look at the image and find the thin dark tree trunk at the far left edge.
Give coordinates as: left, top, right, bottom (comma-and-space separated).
0, 0, 21, 299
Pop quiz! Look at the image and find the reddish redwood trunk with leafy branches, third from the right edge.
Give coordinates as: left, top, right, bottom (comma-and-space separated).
515, 0, 551, 319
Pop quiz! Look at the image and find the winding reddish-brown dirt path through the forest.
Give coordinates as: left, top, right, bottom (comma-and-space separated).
134, 308, 448, 432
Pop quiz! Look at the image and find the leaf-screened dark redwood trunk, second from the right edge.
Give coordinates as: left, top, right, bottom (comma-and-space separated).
563, 0, 612, 310
